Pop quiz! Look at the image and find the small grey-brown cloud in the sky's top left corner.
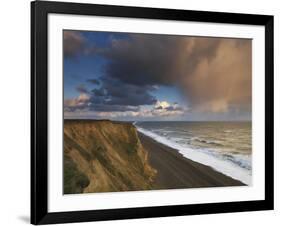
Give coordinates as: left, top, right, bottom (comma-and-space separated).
63, 31, 86, 58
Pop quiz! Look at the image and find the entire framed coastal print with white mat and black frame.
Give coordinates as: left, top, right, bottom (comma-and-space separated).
31, 1, 273, 224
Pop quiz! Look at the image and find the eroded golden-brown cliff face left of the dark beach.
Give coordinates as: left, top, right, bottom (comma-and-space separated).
64, 120, 156, 194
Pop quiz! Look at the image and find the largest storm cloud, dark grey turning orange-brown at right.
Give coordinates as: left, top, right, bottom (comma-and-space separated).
99, 34, 252, 112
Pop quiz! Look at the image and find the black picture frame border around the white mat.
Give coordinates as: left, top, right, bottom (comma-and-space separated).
31, 1, 274, 224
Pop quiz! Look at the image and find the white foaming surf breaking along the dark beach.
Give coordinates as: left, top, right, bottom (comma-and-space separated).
137, 127, 251, 185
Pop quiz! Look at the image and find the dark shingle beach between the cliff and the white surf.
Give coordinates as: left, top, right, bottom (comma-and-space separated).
138, 132, 245, 189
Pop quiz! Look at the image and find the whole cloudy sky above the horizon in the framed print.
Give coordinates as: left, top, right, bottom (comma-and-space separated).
63, 30, 252, 121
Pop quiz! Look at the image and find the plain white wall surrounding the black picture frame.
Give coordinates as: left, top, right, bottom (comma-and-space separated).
0, 0, 281, 226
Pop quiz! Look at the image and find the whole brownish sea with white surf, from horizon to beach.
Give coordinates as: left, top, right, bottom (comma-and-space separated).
134, 121, 252, 185
